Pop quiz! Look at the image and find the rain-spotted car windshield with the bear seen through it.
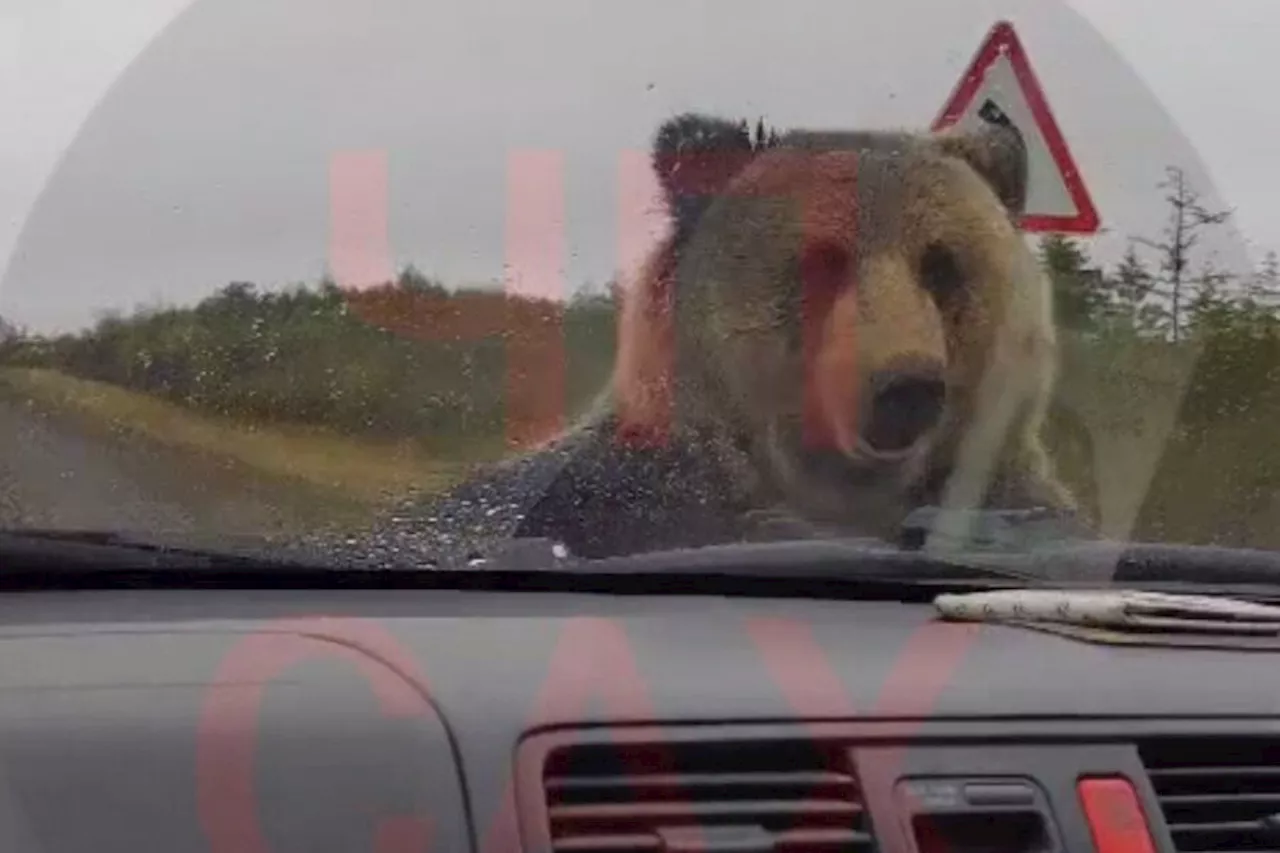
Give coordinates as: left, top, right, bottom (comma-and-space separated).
0, 0, 1280, 566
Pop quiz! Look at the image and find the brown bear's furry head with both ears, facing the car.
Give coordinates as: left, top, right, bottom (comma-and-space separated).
613, 108, 1068, 524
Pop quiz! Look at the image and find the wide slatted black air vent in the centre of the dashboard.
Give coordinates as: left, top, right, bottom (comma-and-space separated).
543, 742, 874, 853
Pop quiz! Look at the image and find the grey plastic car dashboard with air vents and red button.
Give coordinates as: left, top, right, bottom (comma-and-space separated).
0, 589, 1264, 853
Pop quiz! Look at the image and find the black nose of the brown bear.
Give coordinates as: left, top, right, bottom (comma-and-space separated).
863, 366, 947, 453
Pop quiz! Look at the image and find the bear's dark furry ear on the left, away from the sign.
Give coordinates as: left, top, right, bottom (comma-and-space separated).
652, 113, 758, 233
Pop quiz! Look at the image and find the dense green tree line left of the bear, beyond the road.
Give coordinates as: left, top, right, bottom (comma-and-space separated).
0, 268, 614, 443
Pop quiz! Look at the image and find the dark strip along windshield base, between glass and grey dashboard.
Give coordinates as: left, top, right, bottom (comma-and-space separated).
0, 529, 1280, 601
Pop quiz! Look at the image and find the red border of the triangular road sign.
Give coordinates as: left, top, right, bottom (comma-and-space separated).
933, 20, 1101, 234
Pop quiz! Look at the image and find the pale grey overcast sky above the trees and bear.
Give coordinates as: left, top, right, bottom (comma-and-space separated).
0, 0, 1280, 329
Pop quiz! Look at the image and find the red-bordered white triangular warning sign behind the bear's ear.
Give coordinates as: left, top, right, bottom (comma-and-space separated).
933, 20, 1101, 234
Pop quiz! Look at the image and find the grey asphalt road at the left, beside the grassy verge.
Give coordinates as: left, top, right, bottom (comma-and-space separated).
0, 393, 371, 538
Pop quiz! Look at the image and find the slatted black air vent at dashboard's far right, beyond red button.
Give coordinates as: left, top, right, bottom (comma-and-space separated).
1139, 738, 1280, 853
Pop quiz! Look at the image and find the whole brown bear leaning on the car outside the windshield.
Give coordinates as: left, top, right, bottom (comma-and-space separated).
363, 114, 1074, 558
